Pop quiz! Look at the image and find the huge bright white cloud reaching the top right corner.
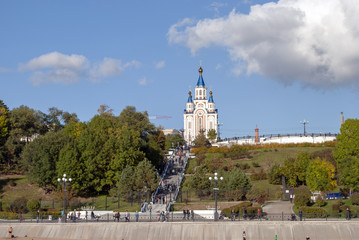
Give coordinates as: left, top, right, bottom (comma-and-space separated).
168, 0, 359, 89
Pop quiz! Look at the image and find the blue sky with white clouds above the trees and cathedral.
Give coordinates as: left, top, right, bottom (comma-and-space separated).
0, 0, 359, 137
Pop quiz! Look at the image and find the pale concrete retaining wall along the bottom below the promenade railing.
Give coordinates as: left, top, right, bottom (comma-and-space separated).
0, 221, 359, 240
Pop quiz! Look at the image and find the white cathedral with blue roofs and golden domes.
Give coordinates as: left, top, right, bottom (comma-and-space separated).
183, 67, 218, 144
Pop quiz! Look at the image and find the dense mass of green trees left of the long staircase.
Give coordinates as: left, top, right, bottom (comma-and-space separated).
0, 100, 183, 195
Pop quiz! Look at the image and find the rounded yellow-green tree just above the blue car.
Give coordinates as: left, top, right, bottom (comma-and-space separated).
306, 158, 337, 191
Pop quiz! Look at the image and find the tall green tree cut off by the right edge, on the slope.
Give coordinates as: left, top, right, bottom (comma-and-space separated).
333, 119, 359, 169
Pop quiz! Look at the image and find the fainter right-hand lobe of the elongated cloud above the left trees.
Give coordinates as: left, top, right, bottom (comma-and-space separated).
89, 58, 140, 80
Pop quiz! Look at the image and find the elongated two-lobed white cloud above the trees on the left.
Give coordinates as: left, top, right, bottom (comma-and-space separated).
19, 52, 140, 85
